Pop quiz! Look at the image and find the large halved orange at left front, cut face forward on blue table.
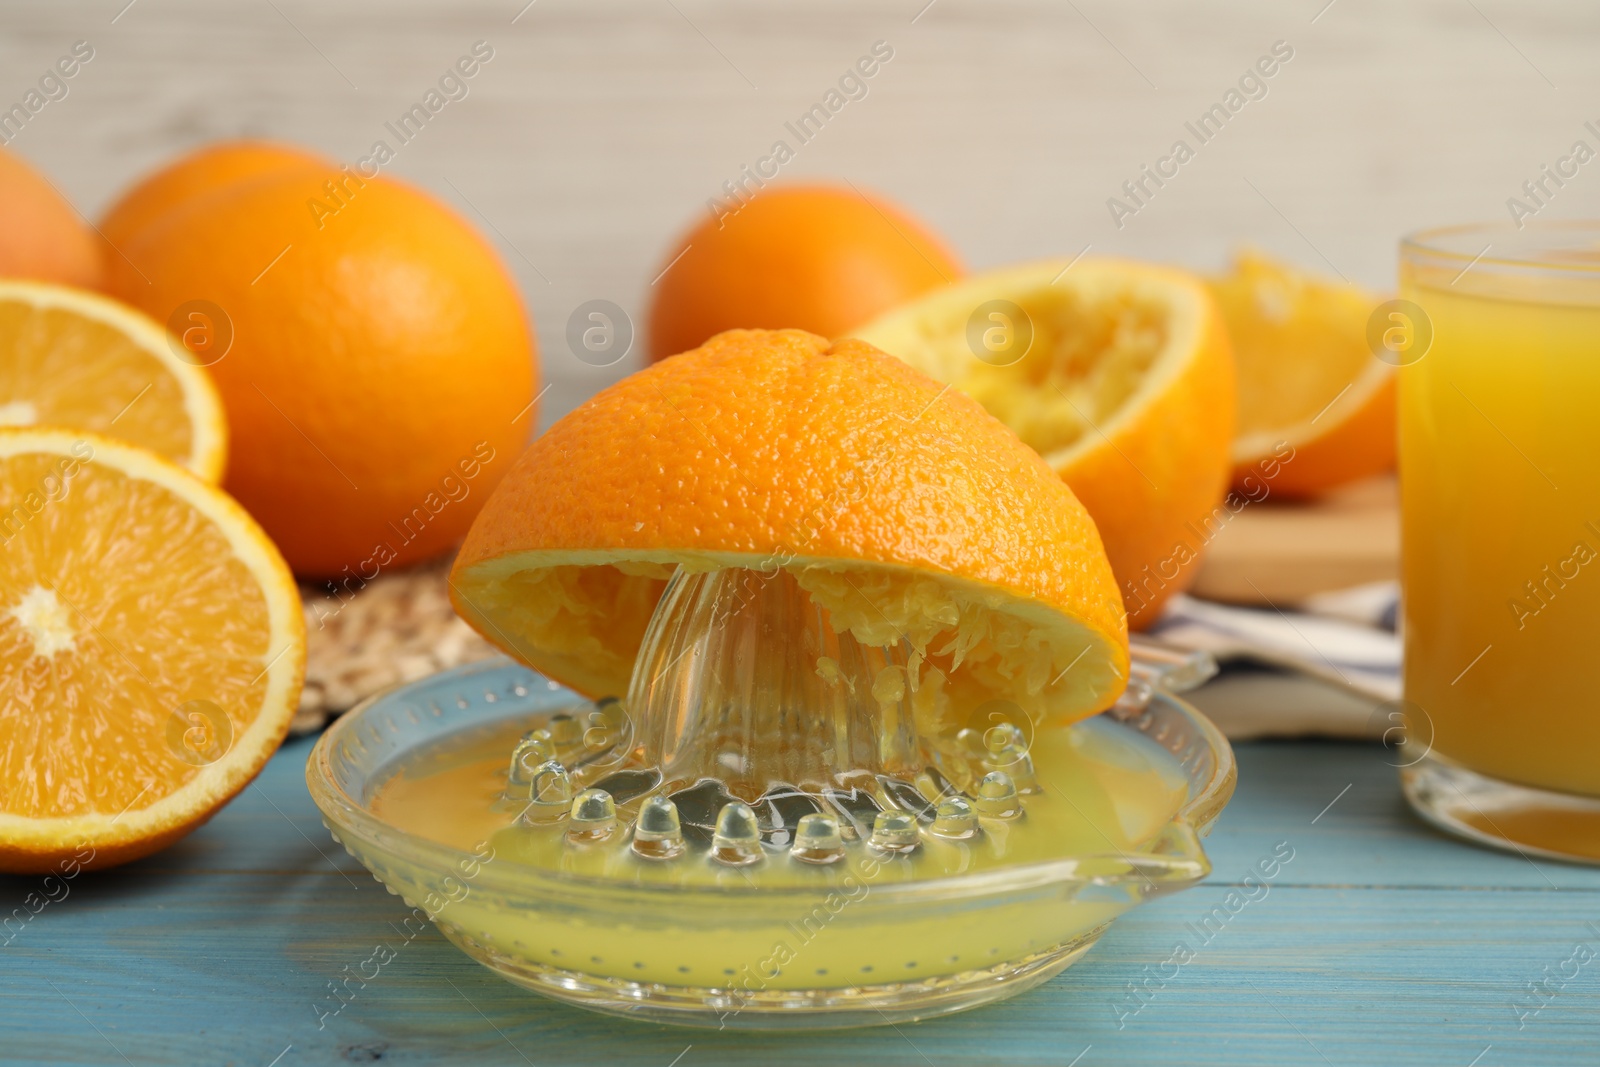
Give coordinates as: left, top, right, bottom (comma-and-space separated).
0, 429, 306, 872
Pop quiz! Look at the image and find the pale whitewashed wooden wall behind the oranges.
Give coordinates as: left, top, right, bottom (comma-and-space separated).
0, 0, 1600, 424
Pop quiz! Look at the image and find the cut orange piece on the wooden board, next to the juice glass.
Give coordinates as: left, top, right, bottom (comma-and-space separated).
1211, 251, 1395, 496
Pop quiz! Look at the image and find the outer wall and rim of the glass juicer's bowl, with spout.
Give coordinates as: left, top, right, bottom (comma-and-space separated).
306, 659, 1235, 1030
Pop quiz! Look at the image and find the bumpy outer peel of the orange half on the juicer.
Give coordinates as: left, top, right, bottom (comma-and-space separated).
451, 330, 1126, 700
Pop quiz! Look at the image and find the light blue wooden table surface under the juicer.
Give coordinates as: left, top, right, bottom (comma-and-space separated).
0, 710, 1600, 1067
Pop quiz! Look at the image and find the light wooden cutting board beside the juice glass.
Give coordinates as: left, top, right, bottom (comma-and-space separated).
1189, 475, 1400, 605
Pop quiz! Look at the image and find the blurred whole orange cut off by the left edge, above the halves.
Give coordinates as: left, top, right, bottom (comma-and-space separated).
0, 149, 101, 290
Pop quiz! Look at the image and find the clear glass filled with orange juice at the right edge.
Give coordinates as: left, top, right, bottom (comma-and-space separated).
1395, 221, 1600, 862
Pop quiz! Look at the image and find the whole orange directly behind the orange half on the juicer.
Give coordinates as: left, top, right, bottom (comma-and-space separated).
650, 186, 962, 360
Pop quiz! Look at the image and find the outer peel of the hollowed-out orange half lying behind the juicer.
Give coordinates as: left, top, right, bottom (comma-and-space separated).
1061, 301, 1235, 630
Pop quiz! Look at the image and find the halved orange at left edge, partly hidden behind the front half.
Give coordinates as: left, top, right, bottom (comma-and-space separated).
0, 280, 227, 482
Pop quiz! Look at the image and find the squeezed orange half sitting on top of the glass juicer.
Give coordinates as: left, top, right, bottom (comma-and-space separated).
451, 330, 1128, 729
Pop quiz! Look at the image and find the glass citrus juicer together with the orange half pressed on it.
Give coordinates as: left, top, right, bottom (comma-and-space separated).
307, 331, 1234, 1029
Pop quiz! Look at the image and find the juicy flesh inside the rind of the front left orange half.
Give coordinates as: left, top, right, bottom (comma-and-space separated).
0, 454, 272, 817
